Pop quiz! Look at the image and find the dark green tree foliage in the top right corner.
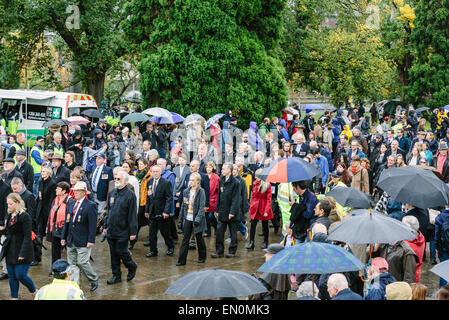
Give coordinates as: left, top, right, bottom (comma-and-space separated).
406, 0, 449, 108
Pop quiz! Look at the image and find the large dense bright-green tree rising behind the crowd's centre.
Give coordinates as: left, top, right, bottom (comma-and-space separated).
123, 0, 287, 125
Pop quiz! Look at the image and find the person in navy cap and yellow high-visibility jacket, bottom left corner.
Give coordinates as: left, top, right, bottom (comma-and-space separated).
34, 259, 86, 300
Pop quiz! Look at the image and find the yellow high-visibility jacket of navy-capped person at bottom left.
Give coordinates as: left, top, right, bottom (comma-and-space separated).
34, 279, 86, 300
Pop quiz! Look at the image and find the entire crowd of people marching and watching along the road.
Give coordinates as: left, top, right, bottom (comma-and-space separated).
0, 105, 449, 300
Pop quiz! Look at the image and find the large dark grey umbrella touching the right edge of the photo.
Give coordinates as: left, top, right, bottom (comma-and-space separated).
377, 166, 449, 209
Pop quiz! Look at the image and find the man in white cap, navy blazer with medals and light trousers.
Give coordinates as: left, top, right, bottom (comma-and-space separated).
61, 181, 98, 291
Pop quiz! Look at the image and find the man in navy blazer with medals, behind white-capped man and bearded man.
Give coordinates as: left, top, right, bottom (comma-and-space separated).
90, 153, 114, 214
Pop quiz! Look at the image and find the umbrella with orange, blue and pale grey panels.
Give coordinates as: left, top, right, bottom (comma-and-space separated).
260, 157, 320, 183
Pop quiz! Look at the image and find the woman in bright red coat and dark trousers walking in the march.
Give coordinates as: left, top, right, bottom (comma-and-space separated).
246, 169, 273, 250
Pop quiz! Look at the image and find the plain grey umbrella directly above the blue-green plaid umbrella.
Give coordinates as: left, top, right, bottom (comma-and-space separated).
328, 209, 417, 244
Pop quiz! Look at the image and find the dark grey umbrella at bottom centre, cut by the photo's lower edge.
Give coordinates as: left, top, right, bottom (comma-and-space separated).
165, 269, 267, 298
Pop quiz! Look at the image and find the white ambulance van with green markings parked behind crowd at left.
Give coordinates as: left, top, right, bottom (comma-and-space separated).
0, 89, 98, 140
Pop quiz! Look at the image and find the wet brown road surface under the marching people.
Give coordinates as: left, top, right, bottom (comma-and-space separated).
0, 224, 439, 300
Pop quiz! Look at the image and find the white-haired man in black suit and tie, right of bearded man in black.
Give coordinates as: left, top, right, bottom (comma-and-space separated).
145, 165, 174, 258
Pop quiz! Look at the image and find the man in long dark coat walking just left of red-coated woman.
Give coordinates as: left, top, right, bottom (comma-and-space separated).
211, 163, 240, 258
